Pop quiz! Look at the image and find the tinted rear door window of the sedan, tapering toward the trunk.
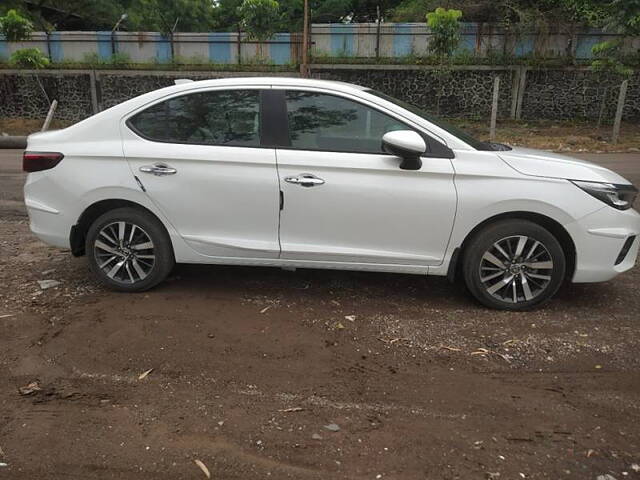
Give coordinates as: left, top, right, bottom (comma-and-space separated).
128, 90, 260, 147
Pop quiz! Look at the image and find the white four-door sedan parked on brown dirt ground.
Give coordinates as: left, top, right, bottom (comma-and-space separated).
24, 78, 640, 310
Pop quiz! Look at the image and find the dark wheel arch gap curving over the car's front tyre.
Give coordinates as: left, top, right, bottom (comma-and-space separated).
447, 211, 576, 281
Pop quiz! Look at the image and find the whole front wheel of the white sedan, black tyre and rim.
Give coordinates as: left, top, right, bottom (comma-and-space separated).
463, 219, 566, 310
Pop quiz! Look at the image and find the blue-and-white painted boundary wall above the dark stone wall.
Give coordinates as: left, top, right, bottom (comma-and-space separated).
0, 23, 640, 65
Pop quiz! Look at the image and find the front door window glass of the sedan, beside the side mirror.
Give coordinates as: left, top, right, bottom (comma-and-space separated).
285, 90, 410, 153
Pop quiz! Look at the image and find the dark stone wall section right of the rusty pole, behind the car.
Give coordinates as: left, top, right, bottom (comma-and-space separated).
314, 65, 640, 121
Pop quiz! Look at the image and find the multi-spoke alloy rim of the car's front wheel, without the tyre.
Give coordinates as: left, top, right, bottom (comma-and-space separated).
480, 235, 553, 303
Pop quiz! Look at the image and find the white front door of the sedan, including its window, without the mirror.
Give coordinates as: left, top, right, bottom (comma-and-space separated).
276, 90, 456, 271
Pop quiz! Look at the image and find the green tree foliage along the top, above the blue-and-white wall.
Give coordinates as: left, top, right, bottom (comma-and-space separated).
0, 0, 640, 34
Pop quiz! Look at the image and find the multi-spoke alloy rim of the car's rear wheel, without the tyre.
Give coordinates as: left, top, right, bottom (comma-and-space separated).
94, 221, 156, 284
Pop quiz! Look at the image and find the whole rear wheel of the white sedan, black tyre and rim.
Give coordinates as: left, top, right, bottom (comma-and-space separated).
85, 208, 175, 292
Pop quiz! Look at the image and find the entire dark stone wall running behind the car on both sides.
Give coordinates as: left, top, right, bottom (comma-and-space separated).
0, 65, 640, 121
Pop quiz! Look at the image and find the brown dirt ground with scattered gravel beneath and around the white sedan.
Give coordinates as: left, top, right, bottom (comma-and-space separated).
0, 151, 640, 480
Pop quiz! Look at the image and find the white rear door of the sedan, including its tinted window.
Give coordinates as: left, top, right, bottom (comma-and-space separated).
122, 87, 280, 258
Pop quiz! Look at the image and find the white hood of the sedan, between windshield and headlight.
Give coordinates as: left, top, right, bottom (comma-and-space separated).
497, 147, 629, 184
